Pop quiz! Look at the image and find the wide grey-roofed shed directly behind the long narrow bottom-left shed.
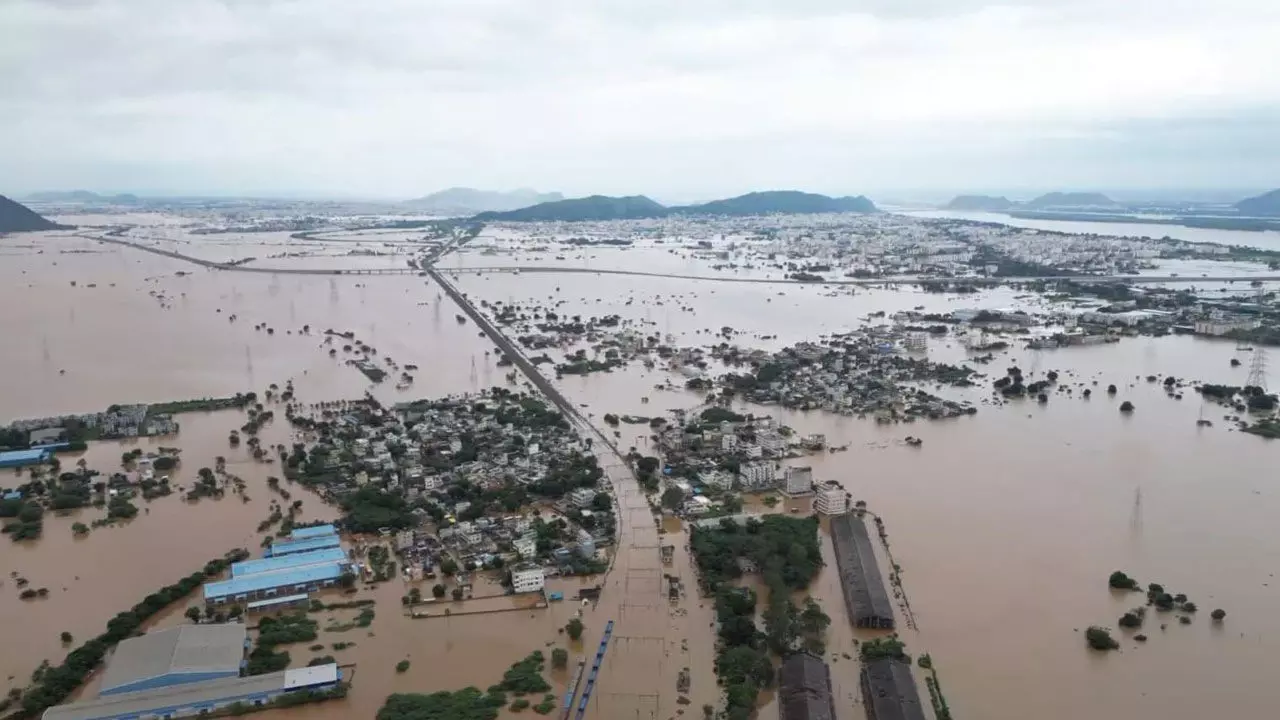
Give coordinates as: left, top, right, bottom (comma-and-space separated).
99, 623, 247, 696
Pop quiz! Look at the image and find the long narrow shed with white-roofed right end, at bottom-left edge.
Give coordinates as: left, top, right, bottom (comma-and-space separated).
42, 665, 342, 720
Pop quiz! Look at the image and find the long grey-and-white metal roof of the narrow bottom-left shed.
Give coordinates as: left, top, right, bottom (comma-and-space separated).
42, 665, 339, 720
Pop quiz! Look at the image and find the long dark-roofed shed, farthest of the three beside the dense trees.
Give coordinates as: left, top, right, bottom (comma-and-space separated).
831, 515, 895, 630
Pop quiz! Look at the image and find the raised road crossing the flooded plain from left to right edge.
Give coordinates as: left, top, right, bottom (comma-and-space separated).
90, 229, 1280, 286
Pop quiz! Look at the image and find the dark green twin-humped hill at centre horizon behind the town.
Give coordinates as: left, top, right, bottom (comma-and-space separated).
475, 190, 878, 222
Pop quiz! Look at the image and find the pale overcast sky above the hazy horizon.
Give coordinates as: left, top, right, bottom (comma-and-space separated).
0, 0, 1280, 199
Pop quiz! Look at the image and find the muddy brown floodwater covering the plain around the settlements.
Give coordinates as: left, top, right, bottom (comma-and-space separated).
0, 220, 1280, 720
